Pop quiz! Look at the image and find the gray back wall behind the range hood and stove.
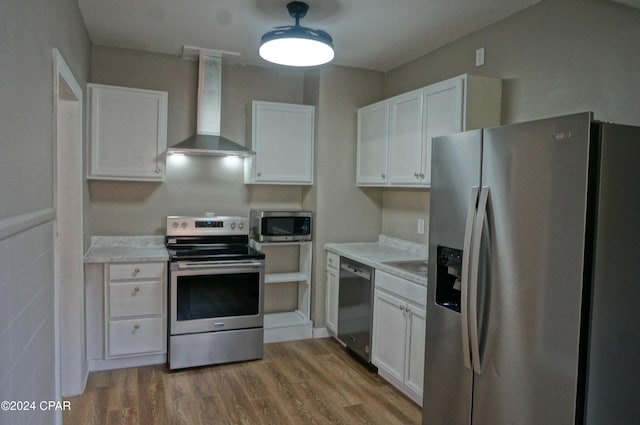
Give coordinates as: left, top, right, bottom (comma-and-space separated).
89, 46, 304, 235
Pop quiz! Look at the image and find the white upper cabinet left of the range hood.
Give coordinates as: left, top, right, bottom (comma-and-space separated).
87, 84, 168, 181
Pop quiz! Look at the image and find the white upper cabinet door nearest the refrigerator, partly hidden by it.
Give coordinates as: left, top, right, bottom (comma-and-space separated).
422, 78, 464, 185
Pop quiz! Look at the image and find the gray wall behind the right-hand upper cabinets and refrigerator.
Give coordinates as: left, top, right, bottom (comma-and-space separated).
383, 0, 640, 245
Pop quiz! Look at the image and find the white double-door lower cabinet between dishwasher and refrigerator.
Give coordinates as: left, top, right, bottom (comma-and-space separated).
371, 270, 427, 405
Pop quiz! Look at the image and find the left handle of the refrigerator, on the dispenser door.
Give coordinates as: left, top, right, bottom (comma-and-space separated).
460, 186, 480, 369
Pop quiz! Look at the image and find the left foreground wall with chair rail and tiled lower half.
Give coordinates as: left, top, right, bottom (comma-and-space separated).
0, 0, 91, 424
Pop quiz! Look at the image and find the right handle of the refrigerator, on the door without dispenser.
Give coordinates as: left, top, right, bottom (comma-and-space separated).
468, 186, 489, 375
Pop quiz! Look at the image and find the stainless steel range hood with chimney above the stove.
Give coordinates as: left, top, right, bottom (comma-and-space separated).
167, 46, 255, 156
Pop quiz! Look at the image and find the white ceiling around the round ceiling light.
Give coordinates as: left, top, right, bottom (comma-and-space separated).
78, 0, 540, 71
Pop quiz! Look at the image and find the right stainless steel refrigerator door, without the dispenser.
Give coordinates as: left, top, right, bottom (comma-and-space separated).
471, 113, 591, 425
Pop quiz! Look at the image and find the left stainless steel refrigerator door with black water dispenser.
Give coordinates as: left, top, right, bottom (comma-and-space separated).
422, 130, 482, 425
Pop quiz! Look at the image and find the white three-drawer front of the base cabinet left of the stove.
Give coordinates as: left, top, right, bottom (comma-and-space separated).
104, 262, 167, 359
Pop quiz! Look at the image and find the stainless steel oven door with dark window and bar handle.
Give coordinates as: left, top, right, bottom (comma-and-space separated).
169, 261, 264, 335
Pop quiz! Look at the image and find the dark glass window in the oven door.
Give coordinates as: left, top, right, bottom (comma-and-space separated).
176, 273, 260, 321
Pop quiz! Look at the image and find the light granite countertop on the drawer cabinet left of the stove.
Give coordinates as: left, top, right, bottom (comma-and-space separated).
84, 236, 169, 263
